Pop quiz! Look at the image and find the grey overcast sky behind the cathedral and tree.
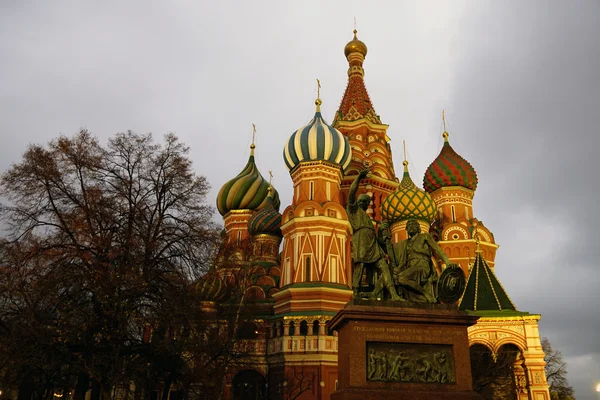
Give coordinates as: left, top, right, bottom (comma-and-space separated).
0, 0, 600, 400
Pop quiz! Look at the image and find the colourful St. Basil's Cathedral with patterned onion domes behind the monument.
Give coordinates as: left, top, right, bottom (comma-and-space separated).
203, 30, 550, 400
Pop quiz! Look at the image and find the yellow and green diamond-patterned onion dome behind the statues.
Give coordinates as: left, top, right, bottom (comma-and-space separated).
381, 160, 436, 224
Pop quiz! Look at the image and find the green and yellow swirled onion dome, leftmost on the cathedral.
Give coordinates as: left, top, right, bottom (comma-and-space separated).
217, 141, 280, 215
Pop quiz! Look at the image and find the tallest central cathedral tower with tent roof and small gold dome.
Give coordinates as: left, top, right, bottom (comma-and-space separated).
332, 29, 398, 221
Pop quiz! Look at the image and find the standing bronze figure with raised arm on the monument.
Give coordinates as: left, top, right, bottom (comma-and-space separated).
346, 167, 402, 300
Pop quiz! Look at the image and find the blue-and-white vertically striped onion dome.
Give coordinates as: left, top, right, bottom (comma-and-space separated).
283, 111, 352, 171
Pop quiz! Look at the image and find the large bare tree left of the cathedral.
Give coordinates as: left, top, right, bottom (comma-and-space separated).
0, 130, 217, 399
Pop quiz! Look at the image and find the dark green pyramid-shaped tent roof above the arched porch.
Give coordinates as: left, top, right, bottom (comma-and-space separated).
458, 245, 517, 312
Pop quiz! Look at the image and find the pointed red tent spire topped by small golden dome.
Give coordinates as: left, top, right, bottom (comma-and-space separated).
334, 29, 381, 124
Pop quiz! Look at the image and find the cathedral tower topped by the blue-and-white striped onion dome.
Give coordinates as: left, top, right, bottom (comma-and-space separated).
275, 91, 352, 314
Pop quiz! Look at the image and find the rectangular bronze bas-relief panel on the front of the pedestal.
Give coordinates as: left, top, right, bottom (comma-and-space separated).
366, 342, 456, 384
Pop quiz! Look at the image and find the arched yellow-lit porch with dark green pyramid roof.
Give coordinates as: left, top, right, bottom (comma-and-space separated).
459, 245, 550, 400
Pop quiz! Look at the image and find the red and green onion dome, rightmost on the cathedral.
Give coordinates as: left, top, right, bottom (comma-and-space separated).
423, 131, 477, 193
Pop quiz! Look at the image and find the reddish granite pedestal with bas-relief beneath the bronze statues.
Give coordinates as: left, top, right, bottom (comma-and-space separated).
329, 300, 480, 400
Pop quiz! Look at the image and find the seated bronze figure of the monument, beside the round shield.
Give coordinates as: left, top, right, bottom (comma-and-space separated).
388, 219, 450, 303
